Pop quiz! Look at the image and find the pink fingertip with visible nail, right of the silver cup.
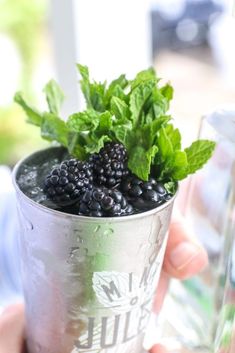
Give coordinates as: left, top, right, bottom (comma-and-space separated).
163, 212, 208, 279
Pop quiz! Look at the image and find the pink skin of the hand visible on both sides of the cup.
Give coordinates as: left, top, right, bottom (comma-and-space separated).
0, 215, 208, 353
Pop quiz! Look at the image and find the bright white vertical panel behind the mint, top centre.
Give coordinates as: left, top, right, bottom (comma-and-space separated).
74, 0, 151, 80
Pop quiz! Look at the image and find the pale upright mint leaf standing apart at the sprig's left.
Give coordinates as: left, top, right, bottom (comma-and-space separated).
43, 80, 64, 115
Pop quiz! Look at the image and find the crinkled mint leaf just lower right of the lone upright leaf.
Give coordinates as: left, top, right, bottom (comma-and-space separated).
67, 109, 99, 132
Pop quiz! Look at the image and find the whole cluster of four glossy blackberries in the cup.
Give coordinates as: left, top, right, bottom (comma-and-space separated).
44, 143, 172, 217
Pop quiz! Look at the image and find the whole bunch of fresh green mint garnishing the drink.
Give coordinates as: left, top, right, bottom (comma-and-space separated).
15, 64, 215, 184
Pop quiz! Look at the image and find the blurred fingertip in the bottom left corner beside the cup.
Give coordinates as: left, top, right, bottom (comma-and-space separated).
0, 304, 24, 353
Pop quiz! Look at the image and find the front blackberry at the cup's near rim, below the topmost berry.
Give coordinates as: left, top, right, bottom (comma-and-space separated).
77, 187, 133, 217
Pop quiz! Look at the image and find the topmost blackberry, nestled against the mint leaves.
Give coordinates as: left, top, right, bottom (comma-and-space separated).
90, 142, 129, 187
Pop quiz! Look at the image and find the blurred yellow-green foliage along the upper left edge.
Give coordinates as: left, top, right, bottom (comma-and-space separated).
0, 0, 48, 165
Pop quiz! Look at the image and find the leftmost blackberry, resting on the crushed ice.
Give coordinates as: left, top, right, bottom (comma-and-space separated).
44, 159, 93, 206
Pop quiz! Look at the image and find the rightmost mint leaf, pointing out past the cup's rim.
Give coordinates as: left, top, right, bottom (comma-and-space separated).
185, 140, 215, 174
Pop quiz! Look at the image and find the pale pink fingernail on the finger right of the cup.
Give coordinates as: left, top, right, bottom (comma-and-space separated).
170, 241, 202, 270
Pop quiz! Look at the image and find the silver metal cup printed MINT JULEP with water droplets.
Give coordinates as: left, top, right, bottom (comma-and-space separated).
13, 150, 174, 353
